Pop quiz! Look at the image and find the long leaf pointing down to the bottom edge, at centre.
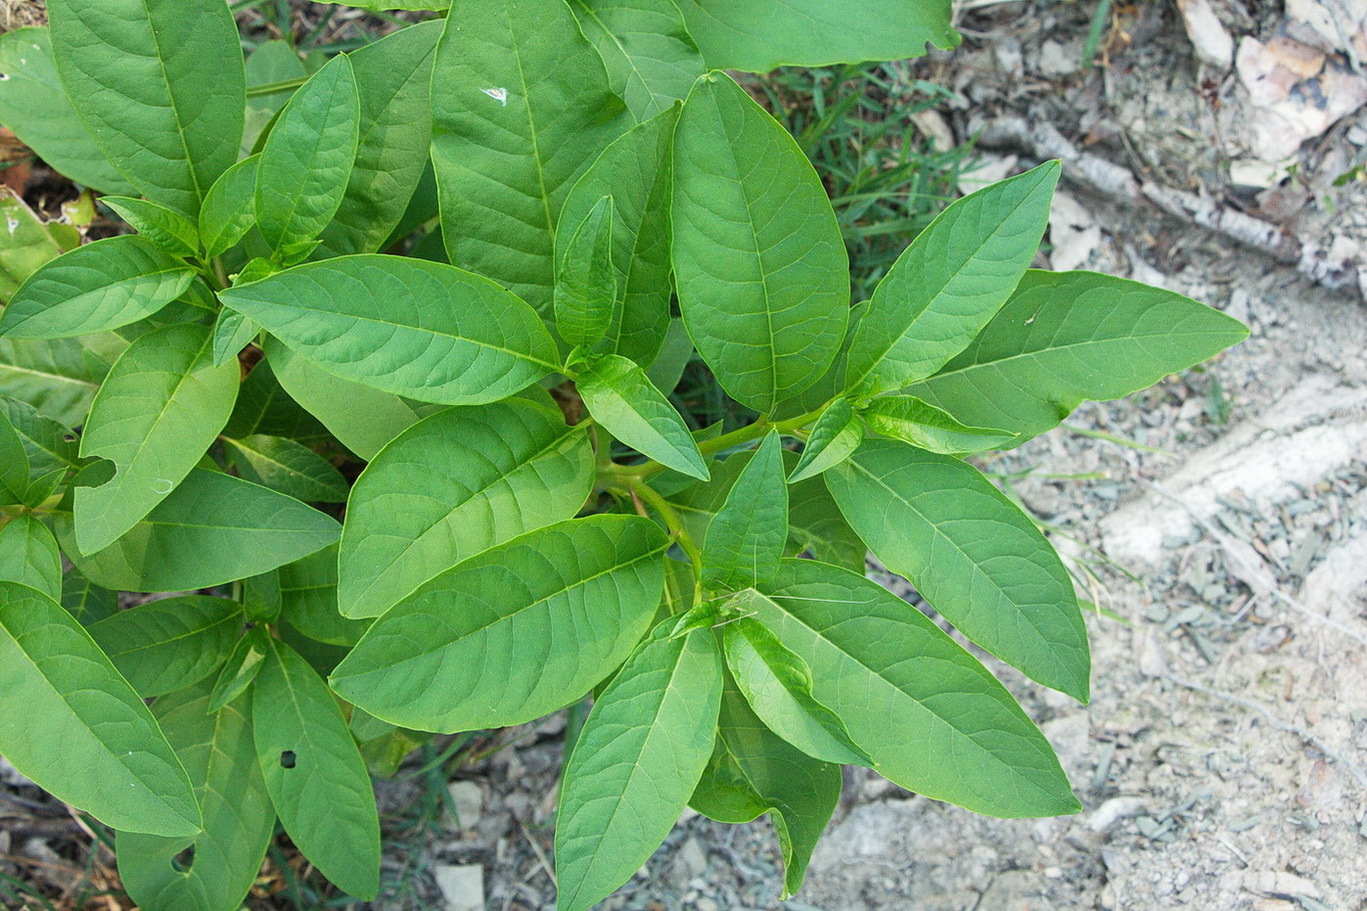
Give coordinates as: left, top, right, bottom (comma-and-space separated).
555, 621, 722, 911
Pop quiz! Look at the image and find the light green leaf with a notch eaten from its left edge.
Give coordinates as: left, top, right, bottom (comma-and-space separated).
74, 323, 238, 554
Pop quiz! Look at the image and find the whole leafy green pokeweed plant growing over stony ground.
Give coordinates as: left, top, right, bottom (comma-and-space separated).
0, 0, 1245, 911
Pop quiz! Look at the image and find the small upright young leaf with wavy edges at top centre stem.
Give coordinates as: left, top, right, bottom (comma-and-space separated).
555, 196, 617, 347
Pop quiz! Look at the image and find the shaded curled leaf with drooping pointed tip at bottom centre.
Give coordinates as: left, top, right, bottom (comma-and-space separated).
689, 672, 843, 897
